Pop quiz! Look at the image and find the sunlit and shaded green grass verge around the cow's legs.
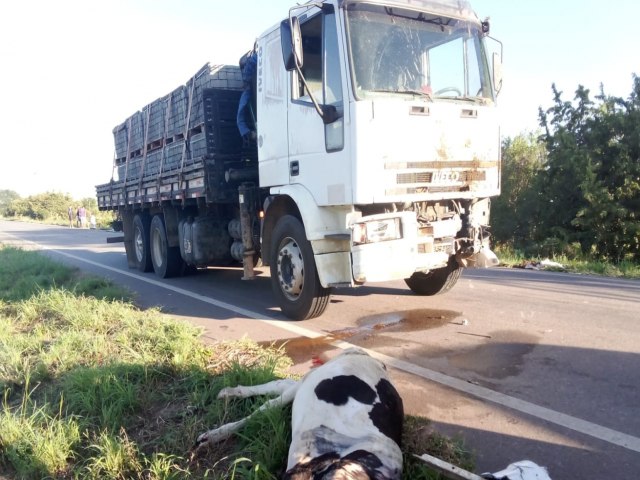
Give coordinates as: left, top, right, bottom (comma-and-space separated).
0, 247, 471, 480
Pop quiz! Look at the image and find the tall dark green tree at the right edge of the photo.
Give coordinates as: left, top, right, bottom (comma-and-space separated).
537, 76, 640, 261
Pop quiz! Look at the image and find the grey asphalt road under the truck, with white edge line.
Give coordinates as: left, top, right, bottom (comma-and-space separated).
0, 221, 640, 480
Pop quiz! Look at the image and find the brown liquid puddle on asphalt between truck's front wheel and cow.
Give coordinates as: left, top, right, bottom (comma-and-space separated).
262, 309, 461, 363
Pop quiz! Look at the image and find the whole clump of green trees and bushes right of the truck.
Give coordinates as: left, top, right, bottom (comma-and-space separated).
493, 76, 640, 263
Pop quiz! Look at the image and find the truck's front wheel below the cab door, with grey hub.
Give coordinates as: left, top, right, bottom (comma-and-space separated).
270, 215, 331, 320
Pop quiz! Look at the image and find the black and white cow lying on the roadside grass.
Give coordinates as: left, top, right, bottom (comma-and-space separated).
197, 348, 404, 480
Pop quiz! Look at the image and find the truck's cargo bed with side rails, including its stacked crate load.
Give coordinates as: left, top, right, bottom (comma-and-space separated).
96, 64, 257, 210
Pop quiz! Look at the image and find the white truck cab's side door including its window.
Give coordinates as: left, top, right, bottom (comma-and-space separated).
288, 9, 352, 205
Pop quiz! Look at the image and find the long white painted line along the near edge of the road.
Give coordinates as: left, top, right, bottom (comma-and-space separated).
5, 233, 640, 453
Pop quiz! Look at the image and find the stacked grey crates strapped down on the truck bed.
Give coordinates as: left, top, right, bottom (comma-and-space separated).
104, 64, 243, 190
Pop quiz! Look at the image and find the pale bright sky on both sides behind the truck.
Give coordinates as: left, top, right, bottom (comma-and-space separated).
0, 0, 640, 200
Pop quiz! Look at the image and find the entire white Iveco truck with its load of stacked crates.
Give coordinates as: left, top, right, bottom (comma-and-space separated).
97, 0, 501, 320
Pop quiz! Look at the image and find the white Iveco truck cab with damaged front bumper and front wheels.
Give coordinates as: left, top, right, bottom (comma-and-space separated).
256, 0, 501, 318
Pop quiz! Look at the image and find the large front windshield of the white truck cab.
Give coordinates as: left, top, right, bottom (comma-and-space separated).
346, 2, 493, 103
